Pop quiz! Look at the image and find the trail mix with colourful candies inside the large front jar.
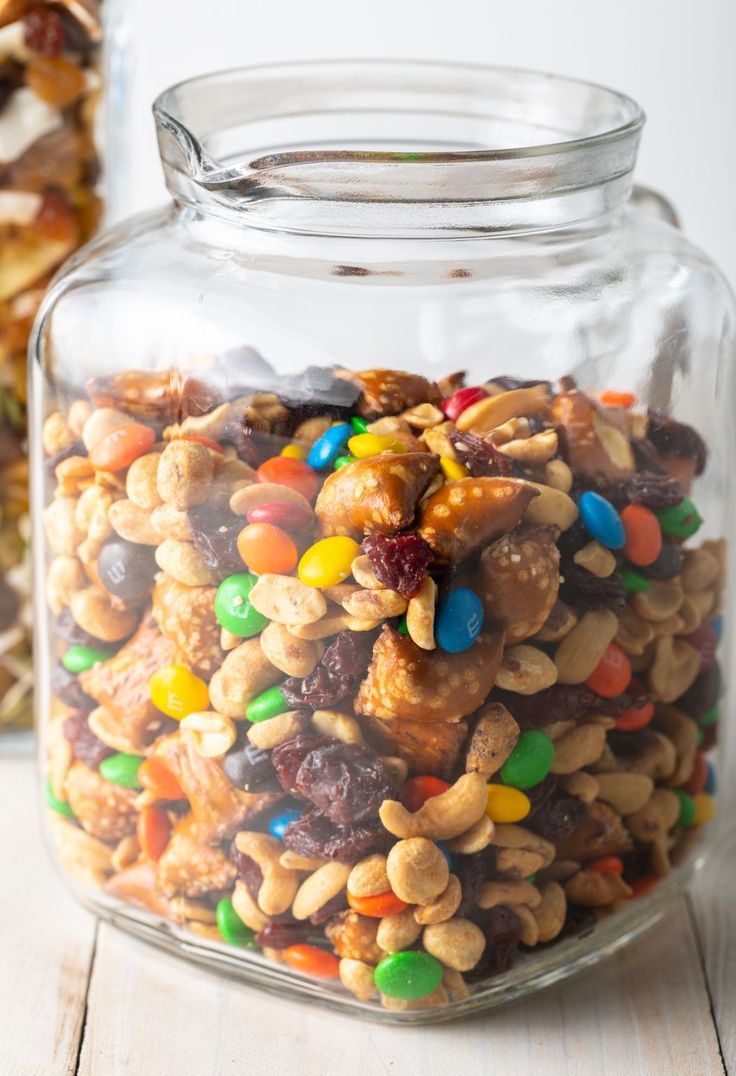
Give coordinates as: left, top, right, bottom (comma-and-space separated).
44, 356, 725, 1009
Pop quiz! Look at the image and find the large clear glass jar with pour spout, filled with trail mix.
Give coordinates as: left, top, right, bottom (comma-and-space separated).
32, 62, 734, 1022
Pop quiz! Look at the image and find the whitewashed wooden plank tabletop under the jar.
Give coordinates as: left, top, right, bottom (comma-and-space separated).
0, 758, 736, 1076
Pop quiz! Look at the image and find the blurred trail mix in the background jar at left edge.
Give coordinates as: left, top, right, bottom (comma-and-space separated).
0, 0, 101, 730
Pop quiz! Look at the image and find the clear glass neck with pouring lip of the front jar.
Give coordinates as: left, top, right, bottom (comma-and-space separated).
155, 61, 643, 238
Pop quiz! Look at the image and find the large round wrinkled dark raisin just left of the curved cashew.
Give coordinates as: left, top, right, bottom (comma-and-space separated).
295, 740, 394, 825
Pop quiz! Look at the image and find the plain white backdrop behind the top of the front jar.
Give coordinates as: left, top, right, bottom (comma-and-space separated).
118, 0, 736, 283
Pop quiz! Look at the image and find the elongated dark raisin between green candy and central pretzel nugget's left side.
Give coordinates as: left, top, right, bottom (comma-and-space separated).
281, 632, 374, 710
